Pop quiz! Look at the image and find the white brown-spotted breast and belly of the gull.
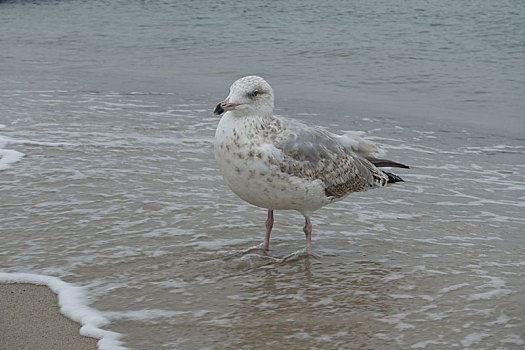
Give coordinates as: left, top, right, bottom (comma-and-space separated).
214, 113, 329, 214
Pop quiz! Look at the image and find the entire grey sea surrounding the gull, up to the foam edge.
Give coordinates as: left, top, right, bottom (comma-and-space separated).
0, 1, 525, 349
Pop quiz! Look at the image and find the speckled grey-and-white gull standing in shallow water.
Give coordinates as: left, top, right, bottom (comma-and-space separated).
214, 76, 408, 255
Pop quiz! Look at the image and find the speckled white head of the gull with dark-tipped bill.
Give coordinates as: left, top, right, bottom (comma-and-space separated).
213, 75, 273, 117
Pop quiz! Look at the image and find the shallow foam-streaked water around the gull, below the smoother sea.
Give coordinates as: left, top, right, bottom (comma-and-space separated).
0, 87, 525, 349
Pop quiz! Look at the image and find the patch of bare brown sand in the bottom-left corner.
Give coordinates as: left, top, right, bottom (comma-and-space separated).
0, 283, 98, 350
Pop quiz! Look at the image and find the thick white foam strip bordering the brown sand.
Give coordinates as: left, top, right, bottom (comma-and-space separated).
0, 272, 128, 350
